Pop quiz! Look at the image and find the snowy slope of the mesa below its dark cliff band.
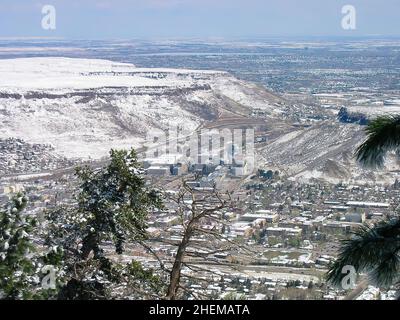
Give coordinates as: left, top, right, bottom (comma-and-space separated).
0, 95, 200, 158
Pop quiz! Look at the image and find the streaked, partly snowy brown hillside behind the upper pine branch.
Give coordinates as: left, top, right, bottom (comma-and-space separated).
260, 120, 399, 183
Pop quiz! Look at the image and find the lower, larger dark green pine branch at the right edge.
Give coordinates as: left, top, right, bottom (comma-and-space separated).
328, 217, 400, 287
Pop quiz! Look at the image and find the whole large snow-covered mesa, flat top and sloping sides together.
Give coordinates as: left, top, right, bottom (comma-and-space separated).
0, 58, 273, 158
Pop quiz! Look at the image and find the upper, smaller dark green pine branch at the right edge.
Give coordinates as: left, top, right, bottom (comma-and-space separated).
356, 115, 400, 168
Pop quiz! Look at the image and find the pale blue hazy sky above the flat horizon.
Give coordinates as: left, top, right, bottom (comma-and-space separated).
0, 0, 400, 39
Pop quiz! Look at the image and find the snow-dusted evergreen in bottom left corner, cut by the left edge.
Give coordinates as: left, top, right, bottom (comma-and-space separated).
0, 193, 62, 300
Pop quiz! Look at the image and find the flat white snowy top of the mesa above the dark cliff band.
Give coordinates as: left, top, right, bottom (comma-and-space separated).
0, 58, 227, 93
